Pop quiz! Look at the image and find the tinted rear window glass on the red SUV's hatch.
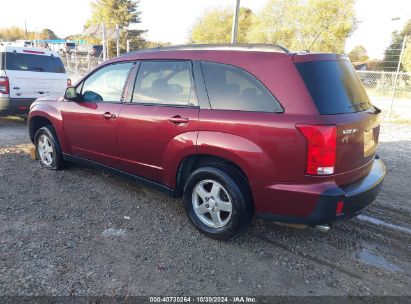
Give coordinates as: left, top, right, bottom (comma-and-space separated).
296, 60, 372, 115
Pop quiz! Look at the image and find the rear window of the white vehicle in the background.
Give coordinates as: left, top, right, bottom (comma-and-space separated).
5, 53, 66, 73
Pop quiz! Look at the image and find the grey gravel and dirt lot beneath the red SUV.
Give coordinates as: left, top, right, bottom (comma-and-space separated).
0, 119, 411, 296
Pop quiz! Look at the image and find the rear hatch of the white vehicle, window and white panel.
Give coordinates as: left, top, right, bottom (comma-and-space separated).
3, 51, 67, 99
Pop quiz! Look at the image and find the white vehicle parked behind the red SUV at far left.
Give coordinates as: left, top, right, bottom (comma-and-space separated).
0, 45, 68, 116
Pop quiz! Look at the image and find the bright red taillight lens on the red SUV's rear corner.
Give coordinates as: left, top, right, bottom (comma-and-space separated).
297, 124, 337, 175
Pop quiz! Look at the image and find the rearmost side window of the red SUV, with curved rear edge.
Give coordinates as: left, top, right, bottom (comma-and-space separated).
201, 61, 283, 112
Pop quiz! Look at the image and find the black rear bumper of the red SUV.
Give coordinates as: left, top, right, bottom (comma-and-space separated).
257, 158, 386, 225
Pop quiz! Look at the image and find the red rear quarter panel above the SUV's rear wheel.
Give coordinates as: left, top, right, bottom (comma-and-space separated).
198, 110, 305, 184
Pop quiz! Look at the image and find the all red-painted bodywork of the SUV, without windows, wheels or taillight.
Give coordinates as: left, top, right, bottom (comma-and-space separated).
29, 50, 386, 223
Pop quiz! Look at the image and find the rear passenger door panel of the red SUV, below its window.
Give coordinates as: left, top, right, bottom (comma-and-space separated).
117, 104, 199, 186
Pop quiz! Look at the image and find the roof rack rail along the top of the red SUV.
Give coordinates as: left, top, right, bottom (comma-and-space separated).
122, 43, 290, 56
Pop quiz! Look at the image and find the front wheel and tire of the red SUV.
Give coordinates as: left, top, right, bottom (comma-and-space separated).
34, 125, 65, 170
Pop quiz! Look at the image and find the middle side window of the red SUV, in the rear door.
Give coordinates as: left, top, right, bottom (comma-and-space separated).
132, 61, 197, 106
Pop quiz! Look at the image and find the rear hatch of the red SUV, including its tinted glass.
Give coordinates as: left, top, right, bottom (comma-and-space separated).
294, 54, 380, 178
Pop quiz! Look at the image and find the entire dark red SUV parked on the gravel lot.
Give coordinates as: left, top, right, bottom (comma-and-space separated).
29, 45, 386, 239
